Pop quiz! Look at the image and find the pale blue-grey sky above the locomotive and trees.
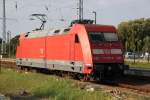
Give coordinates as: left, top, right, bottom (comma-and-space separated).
0, 0, 150, 36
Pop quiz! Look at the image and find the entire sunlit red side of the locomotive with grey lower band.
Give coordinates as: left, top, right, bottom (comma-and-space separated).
16, 25, 92, 74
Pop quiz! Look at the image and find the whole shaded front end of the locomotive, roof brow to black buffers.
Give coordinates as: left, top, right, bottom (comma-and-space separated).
85, 26, 127, 77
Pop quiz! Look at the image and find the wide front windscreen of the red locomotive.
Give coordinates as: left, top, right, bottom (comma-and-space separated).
89, 32, 118, 42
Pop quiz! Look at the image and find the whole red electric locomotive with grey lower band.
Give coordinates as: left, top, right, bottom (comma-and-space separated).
16, 19, 127, 79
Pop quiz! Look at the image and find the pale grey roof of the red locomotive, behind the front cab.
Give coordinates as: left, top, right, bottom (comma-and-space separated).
25, 28, 70, 38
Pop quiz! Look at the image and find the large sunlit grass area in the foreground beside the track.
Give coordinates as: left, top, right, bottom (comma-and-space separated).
0, 69, 111, 100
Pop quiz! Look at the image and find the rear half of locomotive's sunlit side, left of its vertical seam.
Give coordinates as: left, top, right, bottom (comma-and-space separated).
16, 34, 46, 68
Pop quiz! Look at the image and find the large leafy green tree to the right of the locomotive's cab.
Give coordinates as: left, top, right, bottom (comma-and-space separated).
118, 18, 150, 52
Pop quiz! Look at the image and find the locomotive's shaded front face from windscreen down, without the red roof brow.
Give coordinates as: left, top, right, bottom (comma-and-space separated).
89, 32, 124, 71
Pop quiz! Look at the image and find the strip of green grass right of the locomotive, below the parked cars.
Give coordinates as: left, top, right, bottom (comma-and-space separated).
125, 61, 150, 69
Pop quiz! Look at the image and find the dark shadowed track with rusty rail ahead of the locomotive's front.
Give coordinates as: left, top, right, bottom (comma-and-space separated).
103, 75, 150, 95
